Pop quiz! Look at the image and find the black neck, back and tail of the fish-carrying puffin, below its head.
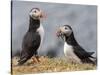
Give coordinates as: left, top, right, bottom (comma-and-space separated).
66, 32, 95, 64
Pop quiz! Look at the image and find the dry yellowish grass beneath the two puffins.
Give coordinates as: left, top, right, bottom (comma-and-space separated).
12, 57, 96, 74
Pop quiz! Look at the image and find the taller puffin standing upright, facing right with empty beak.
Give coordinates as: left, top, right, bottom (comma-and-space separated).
18, 8, 44, 65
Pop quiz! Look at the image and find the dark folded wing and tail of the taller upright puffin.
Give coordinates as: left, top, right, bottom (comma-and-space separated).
18, 32, 41, 65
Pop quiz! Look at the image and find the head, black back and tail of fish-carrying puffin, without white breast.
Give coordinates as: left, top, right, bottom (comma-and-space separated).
57, 25, 96, 64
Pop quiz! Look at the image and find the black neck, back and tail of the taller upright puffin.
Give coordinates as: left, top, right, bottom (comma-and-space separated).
18, 17, 41, 65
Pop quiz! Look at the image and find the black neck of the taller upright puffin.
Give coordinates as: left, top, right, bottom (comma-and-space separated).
29, 17, 40, 31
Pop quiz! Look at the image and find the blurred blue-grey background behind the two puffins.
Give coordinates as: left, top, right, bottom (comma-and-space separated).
12, 0, 97, 57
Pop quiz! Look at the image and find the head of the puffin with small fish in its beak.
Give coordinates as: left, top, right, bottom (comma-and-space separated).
57, 25, 73, 37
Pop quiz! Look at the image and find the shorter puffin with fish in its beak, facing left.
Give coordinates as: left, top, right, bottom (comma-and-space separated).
56, 25, 96, 64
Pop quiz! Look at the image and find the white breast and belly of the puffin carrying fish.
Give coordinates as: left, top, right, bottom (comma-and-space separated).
64, 42, 80, 62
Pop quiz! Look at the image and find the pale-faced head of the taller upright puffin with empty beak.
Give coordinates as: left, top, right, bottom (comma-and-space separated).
29, 8, 43, 19
